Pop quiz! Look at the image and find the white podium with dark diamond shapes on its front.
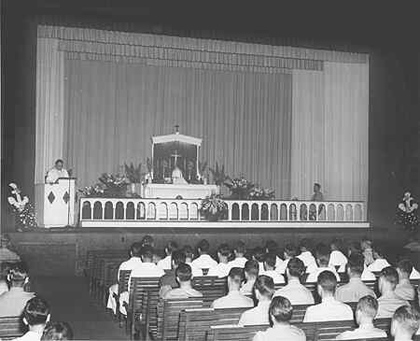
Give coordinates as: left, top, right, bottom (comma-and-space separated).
35, 178, 76, 228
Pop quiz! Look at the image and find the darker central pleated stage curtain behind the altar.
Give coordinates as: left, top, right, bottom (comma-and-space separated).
63, 58, 292, 198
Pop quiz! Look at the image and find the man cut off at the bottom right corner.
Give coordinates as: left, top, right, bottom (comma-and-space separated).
391, 306, 420, 341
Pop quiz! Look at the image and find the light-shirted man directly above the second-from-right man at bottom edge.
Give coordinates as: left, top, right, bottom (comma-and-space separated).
335, 253, 376, 302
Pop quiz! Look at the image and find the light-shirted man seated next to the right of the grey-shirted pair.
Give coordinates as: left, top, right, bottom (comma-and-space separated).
211, 267, 254, 309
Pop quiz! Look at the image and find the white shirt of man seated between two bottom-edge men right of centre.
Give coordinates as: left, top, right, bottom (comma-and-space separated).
303, 297, 353, 322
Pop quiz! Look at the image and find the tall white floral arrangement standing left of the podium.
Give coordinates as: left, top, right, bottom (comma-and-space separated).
7, 182, 38, 232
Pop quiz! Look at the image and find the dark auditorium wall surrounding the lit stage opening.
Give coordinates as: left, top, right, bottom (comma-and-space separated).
2, 0, 420, 234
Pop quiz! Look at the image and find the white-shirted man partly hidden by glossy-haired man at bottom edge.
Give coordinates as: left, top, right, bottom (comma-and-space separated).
238, 274, 275, 326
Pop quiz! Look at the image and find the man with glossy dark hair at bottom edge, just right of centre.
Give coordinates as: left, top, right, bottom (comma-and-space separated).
253, 296, 306, 341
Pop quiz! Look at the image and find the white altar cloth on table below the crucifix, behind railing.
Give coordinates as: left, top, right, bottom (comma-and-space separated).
144, 184, 220, 199
